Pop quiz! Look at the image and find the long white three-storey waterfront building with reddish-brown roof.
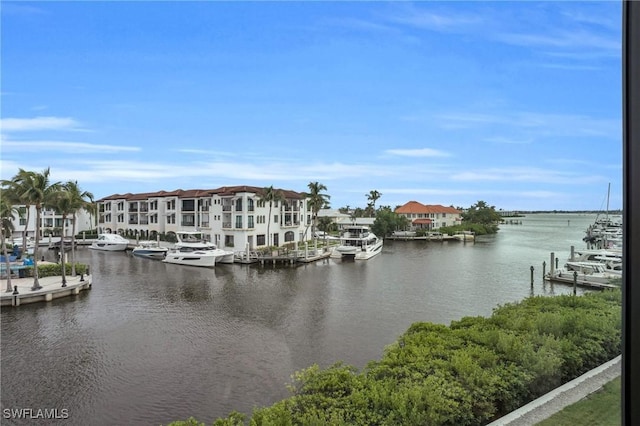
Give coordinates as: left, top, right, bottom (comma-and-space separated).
98, 186, 311, 251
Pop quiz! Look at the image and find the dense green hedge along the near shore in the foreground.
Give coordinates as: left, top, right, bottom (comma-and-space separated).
170, 290, 622, 426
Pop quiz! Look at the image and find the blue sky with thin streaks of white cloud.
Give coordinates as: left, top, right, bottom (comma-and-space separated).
1, 1, 622, 210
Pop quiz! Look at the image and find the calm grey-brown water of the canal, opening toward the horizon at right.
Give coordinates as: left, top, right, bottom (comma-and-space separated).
1, 214, 595, 425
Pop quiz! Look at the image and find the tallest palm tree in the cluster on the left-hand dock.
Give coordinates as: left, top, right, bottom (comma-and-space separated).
17, 168, 60, 290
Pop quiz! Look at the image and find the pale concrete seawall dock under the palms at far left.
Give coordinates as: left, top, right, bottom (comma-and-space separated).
0, 275, 92, 306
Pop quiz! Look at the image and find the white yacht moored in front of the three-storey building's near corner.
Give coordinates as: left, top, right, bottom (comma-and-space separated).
162, 231, 235, 268
